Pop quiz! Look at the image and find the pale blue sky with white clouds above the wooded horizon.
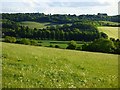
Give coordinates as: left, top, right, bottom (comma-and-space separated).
0, 0, 119, 15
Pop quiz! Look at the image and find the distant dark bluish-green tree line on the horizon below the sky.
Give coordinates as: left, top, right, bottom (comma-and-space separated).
2, 13, 120, 24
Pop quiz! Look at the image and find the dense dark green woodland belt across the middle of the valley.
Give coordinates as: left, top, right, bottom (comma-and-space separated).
2, 20, 108, 41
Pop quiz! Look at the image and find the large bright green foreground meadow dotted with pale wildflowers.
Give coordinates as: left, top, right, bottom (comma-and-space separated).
0, 43, 118, 88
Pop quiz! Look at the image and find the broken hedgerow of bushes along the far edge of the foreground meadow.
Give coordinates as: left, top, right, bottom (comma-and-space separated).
4, 36, 120, 54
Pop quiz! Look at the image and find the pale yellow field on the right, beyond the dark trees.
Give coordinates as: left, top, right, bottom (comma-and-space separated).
98, 27, 119, 39
